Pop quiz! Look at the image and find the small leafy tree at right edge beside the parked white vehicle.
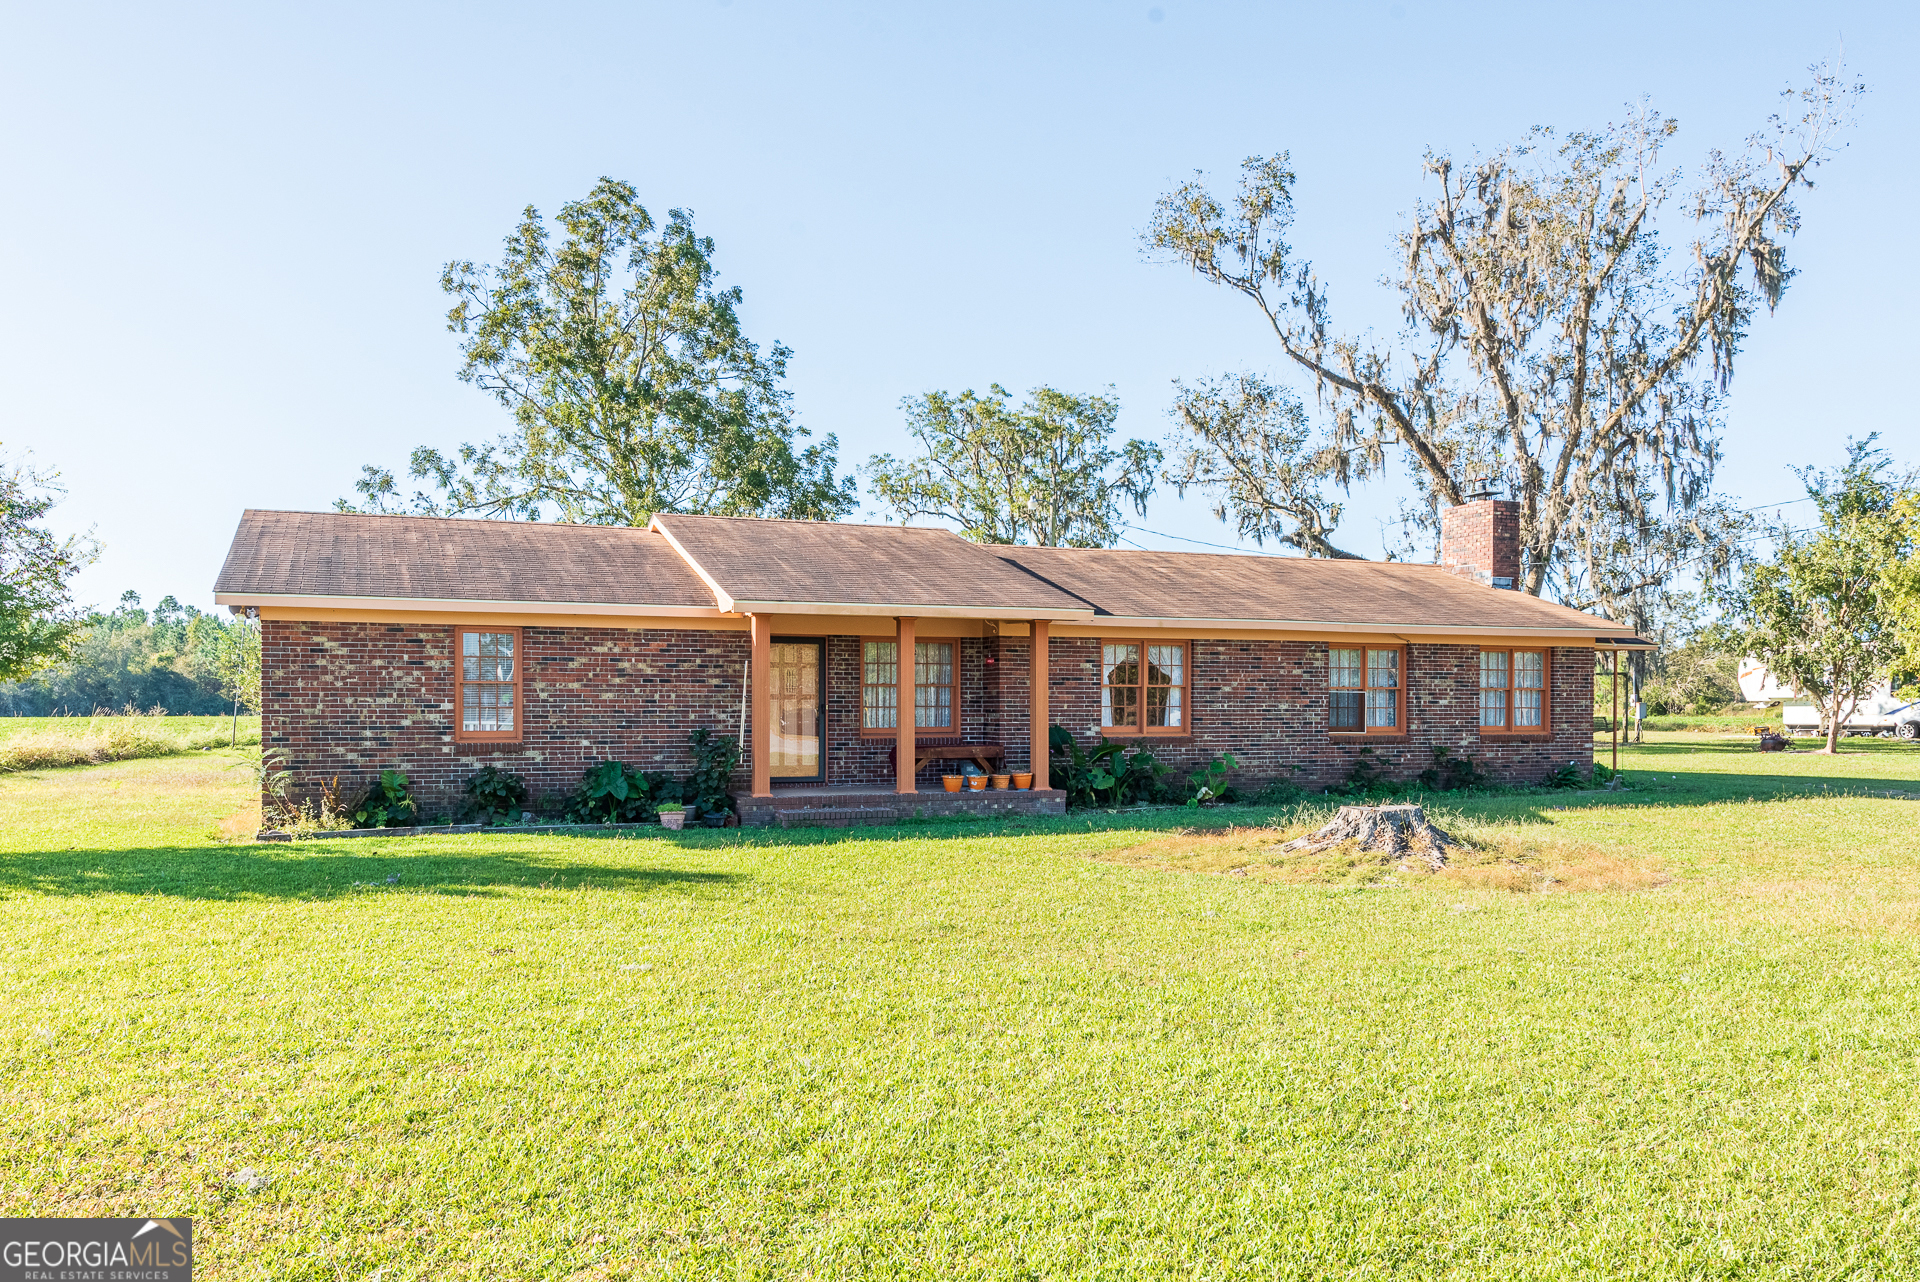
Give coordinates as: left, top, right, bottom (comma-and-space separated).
1722, 438, 1914, 752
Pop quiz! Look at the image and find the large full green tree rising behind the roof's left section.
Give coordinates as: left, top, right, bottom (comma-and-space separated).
336, 178, 854, 526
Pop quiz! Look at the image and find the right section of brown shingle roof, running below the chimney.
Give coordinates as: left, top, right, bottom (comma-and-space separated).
995, 547, 1626, 633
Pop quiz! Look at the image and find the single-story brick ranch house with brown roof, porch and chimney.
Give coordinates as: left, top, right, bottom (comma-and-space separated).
215, 499, 1638, 823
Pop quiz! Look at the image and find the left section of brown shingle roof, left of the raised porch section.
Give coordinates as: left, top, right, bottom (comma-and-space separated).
213, 509, 714, 610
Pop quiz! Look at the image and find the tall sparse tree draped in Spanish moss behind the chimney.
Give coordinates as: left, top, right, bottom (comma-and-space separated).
1144, 69, 1860, 618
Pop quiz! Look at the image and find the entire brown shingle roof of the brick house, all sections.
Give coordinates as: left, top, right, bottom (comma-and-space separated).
213, 510, 1626, 635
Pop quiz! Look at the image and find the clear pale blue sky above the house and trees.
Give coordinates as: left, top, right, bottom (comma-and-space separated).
0, 0, 1920, 606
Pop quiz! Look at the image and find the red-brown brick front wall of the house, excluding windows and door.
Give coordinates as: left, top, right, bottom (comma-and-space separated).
261, 620, 1594, 814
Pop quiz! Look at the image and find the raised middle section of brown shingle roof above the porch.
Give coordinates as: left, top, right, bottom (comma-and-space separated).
653, 514, 1089, 618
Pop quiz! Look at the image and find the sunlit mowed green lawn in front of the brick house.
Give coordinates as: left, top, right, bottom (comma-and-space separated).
0, 735, 1920, 1280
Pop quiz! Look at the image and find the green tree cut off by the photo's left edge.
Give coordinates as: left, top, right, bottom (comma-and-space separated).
0, 445, 96, 681
